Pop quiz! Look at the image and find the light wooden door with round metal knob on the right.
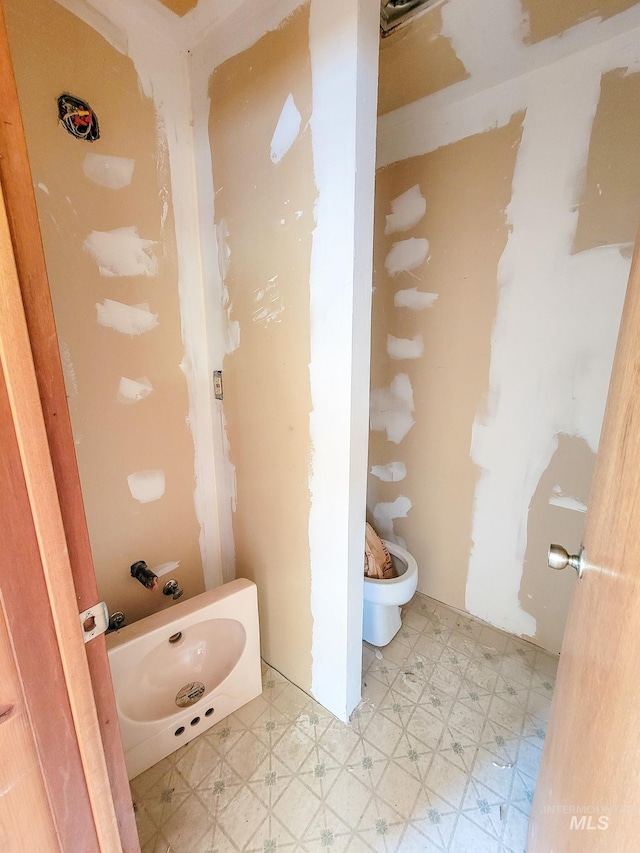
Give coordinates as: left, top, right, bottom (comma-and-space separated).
527, 230, 640, 853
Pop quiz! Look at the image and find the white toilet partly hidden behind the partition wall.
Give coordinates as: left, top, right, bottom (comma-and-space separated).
362, 539, 418, 646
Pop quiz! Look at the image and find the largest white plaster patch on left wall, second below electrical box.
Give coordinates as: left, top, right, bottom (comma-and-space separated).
83, 226, 158, 276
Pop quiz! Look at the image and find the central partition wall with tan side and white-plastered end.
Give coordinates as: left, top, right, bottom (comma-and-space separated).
199, 0, 378, 719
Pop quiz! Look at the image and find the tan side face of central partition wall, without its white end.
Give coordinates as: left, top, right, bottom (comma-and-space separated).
209, 4, 316, 690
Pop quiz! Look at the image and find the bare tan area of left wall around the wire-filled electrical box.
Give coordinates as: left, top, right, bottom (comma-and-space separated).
5, 0, 203, 621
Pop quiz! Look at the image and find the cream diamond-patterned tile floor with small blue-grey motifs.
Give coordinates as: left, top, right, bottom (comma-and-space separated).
131, 594, 557, 853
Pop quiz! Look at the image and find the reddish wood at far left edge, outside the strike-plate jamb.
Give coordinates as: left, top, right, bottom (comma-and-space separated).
0, 250, 98, 851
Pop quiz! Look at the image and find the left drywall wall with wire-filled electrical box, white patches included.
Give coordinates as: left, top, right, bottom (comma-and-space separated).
6, 0, 219, 621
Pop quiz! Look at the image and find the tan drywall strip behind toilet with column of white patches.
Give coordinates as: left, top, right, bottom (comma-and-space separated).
369, 114, 523, 608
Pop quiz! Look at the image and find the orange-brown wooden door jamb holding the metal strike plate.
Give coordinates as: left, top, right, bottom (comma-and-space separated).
0, 3, 140, 853
